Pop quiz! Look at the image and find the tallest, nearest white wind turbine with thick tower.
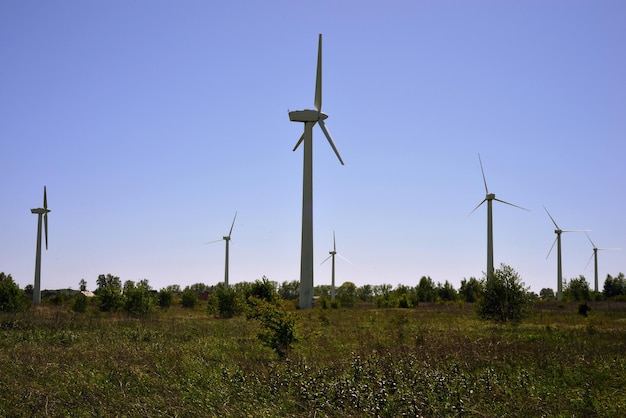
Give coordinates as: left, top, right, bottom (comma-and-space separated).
289, 33, 344, 309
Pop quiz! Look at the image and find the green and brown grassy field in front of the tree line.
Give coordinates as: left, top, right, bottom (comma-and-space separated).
0, 303, 626, 417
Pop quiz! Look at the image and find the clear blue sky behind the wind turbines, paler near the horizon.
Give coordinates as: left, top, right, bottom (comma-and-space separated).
0, 0, 626, 292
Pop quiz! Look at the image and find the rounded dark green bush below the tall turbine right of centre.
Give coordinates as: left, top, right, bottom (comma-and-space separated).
478, 264, 531, 322
